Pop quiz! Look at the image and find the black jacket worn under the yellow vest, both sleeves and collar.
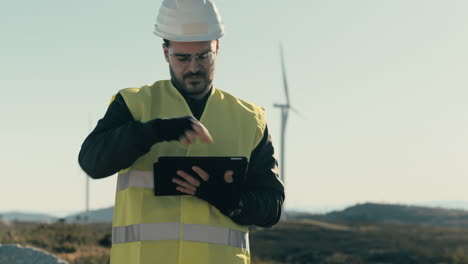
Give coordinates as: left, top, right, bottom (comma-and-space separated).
78, 91, 285, 227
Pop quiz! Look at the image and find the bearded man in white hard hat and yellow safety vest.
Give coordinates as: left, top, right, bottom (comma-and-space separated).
79, 0, 284, 264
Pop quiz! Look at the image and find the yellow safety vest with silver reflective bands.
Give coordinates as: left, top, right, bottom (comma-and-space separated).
107, 80, 266, 264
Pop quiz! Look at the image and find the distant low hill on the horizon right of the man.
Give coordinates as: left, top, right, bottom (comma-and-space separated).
290, 203, 468, 227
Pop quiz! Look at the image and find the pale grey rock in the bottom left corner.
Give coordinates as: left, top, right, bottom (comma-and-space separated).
0, 244, 69, 264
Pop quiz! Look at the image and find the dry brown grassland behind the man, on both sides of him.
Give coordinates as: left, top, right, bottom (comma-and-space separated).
0, 220, 468, 264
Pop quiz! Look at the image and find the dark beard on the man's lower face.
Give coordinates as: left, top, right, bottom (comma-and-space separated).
169, 64, 213, 96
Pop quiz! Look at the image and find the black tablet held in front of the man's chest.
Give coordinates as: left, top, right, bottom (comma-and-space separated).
153, 157, 248, 196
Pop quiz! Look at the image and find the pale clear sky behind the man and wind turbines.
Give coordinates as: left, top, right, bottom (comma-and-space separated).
0, 0, 468, 214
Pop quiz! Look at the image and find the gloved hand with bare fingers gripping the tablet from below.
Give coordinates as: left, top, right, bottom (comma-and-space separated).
172, 166, 240, 216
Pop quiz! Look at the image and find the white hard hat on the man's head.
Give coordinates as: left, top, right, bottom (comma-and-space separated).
154, 0, 224, 42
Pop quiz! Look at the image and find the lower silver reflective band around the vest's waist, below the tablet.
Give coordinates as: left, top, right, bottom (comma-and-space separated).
112, 223, 249, 250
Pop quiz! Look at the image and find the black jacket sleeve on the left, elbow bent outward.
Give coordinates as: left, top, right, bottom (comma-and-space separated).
78, 94, 157, 179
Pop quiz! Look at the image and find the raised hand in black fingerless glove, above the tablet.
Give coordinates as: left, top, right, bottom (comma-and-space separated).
153, 116, 213, 146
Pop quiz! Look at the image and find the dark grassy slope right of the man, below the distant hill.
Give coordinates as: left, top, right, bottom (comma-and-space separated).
250, 220, 468, 264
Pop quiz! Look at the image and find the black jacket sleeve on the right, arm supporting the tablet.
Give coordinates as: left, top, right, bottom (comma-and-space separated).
233, 127, 285, 227
